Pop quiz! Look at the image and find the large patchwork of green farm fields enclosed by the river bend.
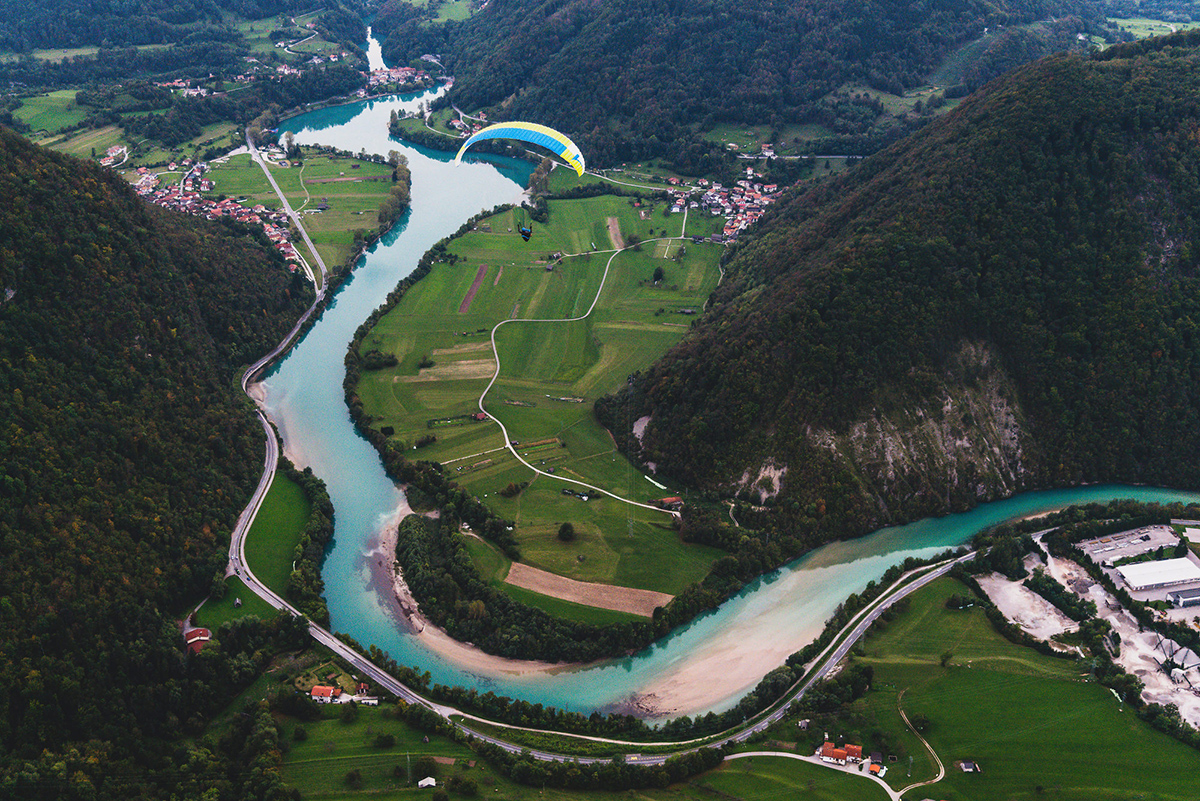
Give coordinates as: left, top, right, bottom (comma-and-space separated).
358, 190, 721, 594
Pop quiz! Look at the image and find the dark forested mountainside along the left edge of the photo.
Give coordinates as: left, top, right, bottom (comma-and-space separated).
0, 128, 312, 799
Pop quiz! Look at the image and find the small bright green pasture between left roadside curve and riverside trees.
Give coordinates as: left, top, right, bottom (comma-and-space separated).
246, 472, 312, 595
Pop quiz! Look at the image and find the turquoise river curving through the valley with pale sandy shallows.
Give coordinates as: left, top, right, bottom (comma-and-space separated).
258, 84, 1200, 717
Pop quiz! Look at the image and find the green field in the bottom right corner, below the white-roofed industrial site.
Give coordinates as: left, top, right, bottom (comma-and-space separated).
793, 578, 1195, 801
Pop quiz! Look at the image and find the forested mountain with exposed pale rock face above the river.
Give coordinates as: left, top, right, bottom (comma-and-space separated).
598, 32, 1200, 551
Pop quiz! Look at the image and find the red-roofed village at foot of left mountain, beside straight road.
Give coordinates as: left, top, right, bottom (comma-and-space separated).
134, 158, 301, 267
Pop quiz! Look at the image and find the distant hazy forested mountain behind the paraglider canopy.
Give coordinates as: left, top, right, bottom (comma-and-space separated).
374, 0, 1093, 163
